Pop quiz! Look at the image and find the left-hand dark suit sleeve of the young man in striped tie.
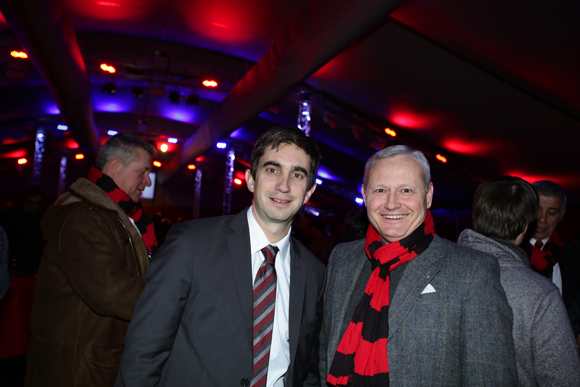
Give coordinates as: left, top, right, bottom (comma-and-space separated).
115, 223, 193, 387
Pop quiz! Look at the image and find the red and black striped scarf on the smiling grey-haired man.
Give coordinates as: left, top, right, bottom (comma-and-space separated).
326, 210, 435, 387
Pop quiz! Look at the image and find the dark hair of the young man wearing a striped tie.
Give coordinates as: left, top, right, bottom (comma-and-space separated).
250, 126, 320, 189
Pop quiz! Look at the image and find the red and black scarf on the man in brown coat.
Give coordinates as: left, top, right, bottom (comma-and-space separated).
89, 167, 157, 256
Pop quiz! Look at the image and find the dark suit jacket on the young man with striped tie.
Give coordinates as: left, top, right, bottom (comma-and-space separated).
115, 210, 325, 387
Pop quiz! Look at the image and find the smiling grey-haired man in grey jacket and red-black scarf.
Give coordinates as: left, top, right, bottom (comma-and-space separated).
320, 145, 517, 387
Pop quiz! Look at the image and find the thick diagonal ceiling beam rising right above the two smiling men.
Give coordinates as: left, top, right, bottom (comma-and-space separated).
159, 0, 405, 183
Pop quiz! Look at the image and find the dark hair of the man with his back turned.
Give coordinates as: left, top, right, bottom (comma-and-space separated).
473, 176, 540, 241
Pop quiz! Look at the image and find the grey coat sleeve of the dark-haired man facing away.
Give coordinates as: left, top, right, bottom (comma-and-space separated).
531, 287, 580, 387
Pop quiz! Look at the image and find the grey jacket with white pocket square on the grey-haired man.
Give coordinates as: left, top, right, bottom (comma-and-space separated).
320, 236, 517, 387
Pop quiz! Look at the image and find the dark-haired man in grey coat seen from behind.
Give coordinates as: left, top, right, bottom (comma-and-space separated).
457, 176, 580, 387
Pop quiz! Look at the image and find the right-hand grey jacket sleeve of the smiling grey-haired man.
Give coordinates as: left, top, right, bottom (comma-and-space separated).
459, 251, 518, 386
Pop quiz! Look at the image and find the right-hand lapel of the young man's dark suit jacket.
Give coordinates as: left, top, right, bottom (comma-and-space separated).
288, 237, 306, 370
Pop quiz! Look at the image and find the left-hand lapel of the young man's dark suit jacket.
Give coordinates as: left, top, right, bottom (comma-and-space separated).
226, 210, 254, 354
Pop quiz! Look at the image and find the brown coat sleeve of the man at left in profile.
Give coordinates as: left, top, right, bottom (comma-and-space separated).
58, 207, 145, 320
